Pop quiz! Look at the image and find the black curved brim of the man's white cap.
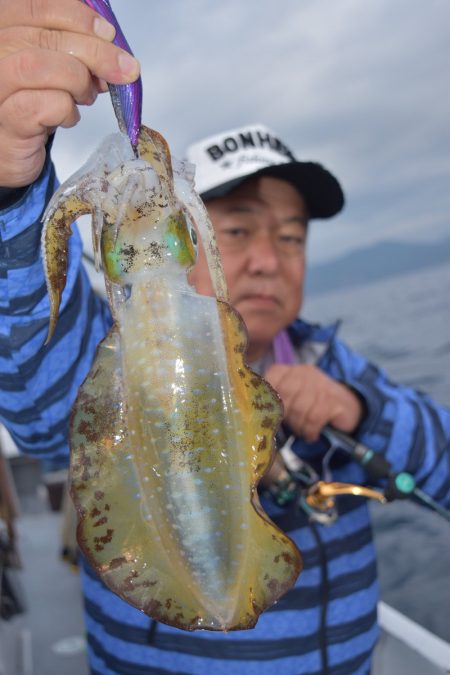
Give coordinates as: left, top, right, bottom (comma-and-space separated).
200, 162, 345, 218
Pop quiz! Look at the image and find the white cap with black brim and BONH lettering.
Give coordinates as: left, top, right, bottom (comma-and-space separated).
186, 124, 344, 218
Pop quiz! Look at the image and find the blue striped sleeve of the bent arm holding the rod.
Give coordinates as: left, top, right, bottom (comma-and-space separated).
322, 340, 450, 505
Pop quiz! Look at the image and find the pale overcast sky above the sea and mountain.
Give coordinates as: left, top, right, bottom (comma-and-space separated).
54, 0, 450, 262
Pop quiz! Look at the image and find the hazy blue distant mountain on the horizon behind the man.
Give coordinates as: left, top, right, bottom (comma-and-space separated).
306, 239, 450, 295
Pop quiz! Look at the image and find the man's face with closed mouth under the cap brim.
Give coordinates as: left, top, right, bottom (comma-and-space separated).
190, 176, 308, 361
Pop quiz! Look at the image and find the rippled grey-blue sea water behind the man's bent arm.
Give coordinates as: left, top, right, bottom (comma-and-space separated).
303, 264, 450, 641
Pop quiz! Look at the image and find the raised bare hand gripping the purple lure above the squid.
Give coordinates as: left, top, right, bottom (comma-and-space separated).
0, 0, 139, 187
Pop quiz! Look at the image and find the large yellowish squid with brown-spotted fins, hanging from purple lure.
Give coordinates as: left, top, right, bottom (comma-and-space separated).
42, 0, 301, 631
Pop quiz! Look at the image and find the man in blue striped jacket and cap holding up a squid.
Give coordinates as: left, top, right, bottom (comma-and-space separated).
0, 0, 450, 675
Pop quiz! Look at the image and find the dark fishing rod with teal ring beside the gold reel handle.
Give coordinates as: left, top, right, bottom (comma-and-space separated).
322, 425, 450, 522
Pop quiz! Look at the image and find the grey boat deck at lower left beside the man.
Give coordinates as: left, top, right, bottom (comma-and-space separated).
0, 456, 89, 675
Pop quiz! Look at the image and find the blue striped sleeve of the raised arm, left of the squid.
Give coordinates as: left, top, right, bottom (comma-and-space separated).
0, 150, 109, 462
